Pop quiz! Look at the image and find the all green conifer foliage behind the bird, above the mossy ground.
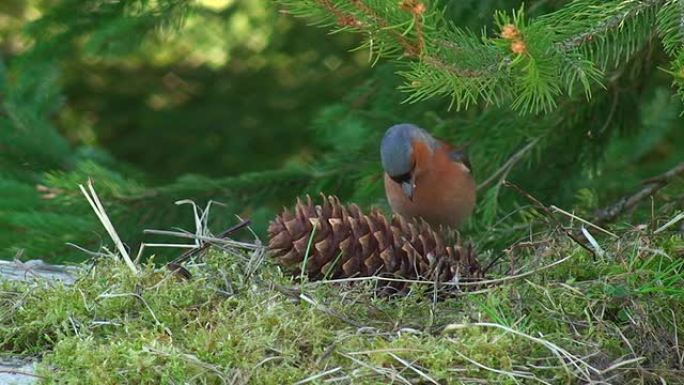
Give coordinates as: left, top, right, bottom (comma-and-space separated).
0, 0, 684, 261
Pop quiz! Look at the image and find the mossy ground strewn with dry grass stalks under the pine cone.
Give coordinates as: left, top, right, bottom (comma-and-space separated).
0, 212, 684, 384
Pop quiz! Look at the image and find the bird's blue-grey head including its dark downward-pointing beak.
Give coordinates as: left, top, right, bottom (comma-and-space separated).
380, 123, 439, 200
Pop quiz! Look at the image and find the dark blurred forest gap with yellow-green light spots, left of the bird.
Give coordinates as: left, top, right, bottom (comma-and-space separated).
0, 0, 368, 179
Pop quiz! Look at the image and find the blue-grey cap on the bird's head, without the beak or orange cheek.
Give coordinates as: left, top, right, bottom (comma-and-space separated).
380, 123, 439, 177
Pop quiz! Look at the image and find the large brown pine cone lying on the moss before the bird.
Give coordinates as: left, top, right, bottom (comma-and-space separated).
268, 195, 482, 289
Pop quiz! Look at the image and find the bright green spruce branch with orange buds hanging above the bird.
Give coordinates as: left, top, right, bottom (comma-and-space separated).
281, 0, 678, 113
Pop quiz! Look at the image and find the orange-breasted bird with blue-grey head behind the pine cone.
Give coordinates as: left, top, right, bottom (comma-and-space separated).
380, 123, 476, 228
